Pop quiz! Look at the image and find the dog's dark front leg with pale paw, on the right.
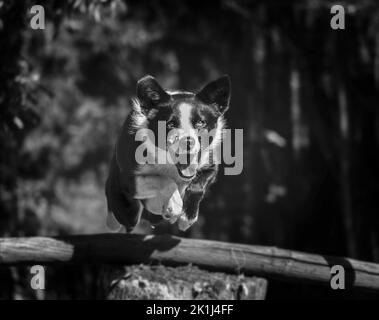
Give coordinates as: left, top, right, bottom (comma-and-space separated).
178, 166, 218, 231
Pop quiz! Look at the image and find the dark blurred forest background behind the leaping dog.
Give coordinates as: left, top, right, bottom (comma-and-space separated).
0, 0, 379, 299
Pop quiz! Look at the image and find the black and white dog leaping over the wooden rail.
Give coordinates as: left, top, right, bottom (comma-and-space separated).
106, 76, 230, 232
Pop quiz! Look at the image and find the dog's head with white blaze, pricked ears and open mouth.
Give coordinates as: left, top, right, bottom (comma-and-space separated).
136, 76, 230, 180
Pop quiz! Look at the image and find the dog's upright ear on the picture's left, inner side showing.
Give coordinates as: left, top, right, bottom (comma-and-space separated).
137, 75, 170, 109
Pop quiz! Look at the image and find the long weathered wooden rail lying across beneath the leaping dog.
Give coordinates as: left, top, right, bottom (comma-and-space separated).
0, 234, 379, 291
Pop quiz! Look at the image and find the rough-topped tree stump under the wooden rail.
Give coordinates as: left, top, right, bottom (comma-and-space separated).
104, 265, 267, 300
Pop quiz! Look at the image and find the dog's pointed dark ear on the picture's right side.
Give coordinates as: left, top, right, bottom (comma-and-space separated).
196, 75, 231, 114
